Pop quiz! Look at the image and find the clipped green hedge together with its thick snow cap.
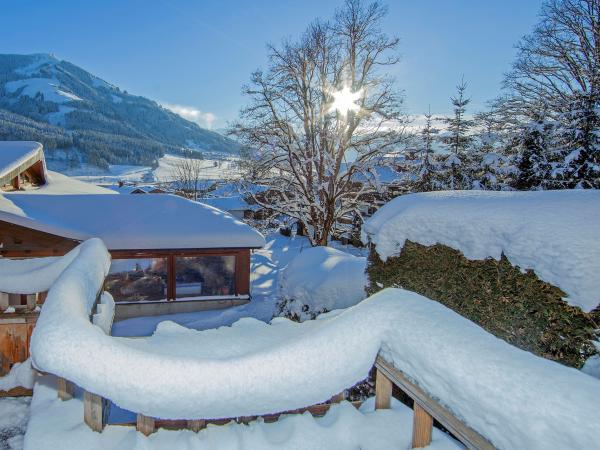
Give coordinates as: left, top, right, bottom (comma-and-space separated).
365, 191, 600, 367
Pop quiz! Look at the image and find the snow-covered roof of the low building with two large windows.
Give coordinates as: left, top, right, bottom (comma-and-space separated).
0, 193, 265, 250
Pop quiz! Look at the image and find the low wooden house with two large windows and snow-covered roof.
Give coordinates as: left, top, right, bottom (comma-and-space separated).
0, 143, 264, 320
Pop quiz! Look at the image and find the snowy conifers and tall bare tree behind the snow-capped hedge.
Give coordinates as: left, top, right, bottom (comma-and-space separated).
405, 0, 600, 190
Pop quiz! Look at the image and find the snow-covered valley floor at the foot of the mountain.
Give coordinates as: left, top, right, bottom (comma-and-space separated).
47, 154, 240, 184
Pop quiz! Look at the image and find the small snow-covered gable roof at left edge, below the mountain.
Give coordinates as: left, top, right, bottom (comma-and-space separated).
0, 141, 44, 186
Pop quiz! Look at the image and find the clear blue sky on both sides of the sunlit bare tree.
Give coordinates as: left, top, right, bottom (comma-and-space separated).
0, 0, 542, 128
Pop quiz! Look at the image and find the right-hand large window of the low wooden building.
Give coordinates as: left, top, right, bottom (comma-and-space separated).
175, 255, 236, 298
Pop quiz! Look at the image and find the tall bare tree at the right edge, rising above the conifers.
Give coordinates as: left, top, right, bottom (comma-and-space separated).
506, 0, 600, 187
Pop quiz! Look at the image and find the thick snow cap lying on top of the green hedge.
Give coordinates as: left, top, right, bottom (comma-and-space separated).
363, 190, 600, 312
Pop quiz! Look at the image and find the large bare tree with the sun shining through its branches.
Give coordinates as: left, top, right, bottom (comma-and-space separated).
231, 0, 403, 245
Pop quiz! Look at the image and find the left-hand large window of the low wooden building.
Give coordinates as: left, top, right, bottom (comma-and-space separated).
106, 258, 168, 302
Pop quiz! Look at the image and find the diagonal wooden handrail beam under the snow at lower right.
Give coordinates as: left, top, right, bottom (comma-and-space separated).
375, 356, 495, 450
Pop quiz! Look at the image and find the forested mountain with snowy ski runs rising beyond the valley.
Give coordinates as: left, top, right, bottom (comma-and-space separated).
0, 54, 238, 167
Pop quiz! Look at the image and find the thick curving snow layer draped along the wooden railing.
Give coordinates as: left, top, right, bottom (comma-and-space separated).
10, 240, 600, 449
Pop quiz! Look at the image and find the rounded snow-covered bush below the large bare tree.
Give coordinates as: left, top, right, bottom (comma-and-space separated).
280, 247, 368, 320
